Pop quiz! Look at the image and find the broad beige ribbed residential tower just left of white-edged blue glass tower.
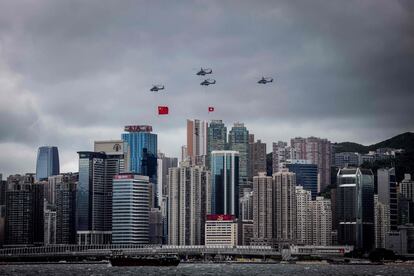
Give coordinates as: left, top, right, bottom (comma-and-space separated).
168, 161, 210, 245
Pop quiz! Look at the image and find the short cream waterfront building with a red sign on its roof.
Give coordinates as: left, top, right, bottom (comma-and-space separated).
205, 215, 238, 247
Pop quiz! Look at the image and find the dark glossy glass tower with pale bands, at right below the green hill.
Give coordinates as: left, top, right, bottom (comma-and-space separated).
336, 168, 374, 251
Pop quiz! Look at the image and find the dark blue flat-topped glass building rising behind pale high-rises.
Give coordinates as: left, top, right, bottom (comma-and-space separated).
286, 163, 318, 200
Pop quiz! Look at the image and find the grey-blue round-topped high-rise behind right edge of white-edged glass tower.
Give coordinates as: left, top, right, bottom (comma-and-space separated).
228, 123, 247, 195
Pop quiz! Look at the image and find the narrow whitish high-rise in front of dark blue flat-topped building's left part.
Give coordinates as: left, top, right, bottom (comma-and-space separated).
296, 186, 312, 245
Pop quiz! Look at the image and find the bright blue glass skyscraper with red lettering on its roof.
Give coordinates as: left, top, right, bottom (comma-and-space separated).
122, 125, 158, 183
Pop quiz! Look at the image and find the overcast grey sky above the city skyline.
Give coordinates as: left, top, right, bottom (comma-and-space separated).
0, 0, 414, 178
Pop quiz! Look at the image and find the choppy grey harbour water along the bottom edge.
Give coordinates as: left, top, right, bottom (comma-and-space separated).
0, 264, 414, 276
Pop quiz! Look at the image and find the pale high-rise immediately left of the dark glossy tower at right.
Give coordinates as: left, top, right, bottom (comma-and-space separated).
310, 196, 332, 246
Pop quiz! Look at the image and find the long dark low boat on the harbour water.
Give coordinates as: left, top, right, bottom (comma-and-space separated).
110, 256, 180, 266
